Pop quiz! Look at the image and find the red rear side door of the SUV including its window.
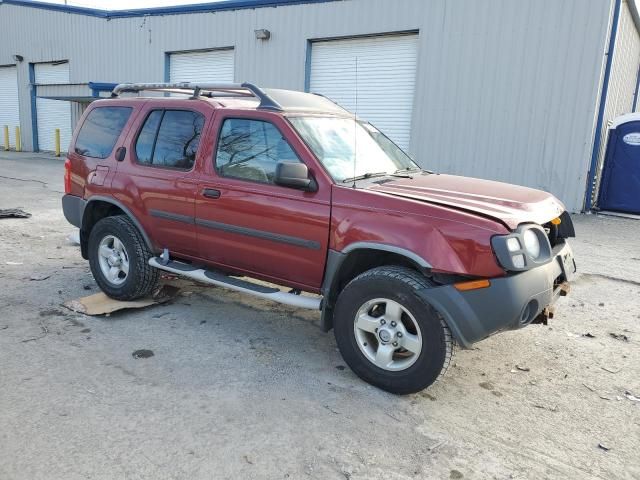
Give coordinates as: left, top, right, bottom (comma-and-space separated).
113, 106, 209, 256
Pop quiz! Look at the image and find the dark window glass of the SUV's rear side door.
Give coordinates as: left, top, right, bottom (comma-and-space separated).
136, 110, 204, 170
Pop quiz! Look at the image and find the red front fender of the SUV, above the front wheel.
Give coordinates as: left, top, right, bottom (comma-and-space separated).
330, 185, 508, 277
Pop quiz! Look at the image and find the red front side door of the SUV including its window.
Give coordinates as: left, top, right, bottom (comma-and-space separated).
196, 111, 331, 291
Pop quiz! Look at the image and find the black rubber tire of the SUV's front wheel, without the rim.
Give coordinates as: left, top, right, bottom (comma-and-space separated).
334, 266, 454, 394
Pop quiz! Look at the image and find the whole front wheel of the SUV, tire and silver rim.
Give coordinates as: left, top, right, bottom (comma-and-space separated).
334, 266, 454, 394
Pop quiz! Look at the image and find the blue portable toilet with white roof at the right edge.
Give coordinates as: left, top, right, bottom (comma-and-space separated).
598, 113, 640, 214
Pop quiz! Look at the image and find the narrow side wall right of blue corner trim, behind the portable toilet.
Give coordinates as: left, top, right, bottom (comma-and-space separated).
592, 0, 640, 205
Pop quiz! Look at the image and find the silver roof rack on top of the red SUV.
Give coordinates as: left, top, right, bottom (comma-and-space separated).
111, 82, 283, 111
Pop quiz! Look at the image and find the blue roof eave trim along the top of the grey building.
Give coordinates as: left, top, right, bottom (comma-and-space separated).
0, 0, 342, 20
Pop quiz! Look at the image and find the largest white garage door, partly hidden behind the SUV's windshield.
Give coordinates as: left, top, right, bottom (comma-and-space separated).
309, 35, 418, 149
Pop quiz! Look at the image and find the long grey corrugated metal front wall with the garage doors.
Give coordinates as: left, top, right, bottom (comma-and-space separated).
0, 0, 611, 211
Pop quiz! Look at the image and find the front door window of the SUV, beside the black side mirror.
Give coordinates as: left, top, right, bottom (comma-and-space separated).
216, 118, 300, 183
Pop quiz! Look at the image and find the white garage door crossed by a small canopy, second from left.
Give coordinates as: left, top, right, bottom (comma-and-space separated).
34, 62, 72, 151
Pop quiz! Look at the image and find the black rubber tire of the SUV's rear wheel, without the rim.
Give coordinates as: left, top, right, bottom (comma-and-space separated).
89, 215, 159, 300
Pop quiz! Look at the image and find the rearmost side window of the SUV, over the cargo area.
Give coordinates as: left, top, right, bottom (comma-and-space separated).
75, 107, 131, 158
